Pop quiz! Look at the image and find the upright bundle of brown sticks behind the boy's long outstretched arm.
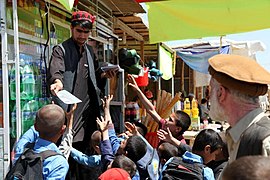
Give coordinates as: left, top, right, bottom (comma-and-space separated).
143, 90, 181, 148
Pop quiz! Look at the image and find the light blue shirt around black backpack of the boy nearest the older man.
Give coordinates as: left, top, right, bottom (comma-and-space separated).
159, 151, 215, 180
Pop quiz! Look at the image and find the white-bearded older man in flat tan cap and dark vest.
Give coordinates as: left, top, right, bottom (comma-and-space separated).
208, 54, 270, 163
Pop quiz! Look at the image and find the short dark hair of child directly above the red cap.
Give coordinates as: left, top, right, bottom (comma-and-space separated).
112, 155, 137, 177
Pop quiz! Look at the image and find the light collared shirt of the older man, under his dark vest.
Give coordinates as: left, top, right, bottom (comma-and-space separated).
226, 108, 270, 163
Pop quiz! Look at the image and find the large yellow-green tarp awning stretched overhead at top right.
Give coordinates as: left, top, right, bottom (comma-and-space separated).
147, 0, 270, 43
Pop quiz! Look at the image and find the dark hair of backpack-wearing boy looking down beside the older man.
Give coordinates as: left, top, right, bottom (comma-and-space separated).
192, 129, 223, 153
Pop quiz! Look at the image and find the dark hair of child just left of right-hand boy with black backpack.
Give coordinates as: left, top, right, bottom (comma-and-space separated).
158, 142, 178, 161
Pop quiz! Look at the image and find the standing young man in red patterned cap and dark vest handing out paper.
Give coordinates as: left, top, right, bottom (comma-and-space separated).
47, 11, 115, 152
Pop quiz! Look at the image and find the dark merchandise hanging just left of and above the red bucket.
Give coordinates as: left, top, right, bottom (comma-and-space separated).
118, 48, 143, 75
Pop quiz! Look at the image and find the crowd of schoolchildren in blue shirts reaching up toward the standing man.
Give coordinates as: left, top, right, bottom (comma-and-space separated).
7, 68, 270, 180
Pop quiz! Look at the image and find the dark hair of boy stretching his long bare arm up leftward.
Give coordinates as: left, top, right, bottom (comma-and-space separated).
174, 110, 191, 135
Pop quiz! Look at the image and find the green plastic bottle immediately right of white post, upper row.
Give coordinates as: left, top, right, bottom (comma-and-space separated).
21, 56, 35, 100
